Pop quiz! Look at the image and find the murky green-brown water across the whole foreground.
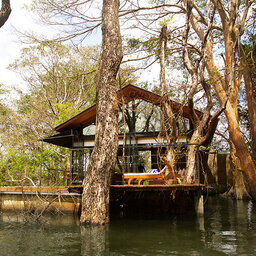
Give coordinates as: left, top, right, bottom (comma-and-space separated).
0, 197, 256, 256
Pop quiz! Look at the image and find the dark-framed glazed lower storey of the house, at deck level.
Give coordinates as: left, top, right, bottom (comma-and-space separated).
56, 143, 206, 185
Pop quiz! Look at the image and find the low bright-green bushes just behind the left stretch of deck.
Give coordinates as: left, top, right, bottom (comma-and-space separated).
0, 146, 68, 186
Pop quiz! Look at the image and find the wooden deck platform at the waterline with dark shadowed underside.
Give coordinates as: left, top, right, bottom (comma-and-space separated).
0, 184, 204, 216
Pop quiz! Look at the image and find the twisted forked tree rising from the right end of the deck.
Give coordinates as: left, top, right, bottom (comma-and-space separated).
183, 0, 221, 184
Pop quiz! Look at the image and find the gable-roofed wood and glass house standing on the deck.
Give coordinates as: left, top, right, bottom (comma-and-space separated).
43, 85, 208, 184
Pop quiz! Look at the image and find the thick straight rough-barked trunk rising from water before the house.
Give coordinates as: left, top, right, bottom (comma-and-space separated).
80, 0, 123, 224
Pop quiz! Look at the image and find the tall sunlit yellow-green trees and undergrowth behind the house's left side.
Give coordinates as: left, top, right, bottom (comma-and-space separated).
0, 41, 140, 185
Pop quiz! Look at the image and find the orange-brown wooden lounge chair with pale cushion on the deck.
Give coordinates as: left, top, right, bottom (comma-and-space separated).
124, 167, 166, 185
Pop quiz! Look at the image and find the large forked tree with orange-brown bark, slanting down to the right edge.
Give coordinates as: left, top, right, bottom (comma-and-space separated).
184, 0, 256, 199
